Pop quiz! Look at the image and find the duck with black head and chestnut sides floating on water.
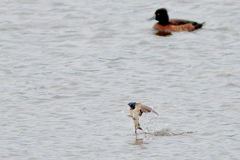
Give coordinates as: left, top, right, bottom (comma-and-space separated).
152, 8, 205, 33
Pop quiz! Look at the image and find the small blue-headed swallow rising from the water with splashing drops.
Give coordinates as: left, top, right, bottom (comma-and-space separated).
128, 102, 158, 134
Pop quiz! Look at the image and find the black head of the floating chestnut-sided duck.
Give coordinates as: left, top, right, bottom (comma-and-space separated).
155, 8, 169, 26
